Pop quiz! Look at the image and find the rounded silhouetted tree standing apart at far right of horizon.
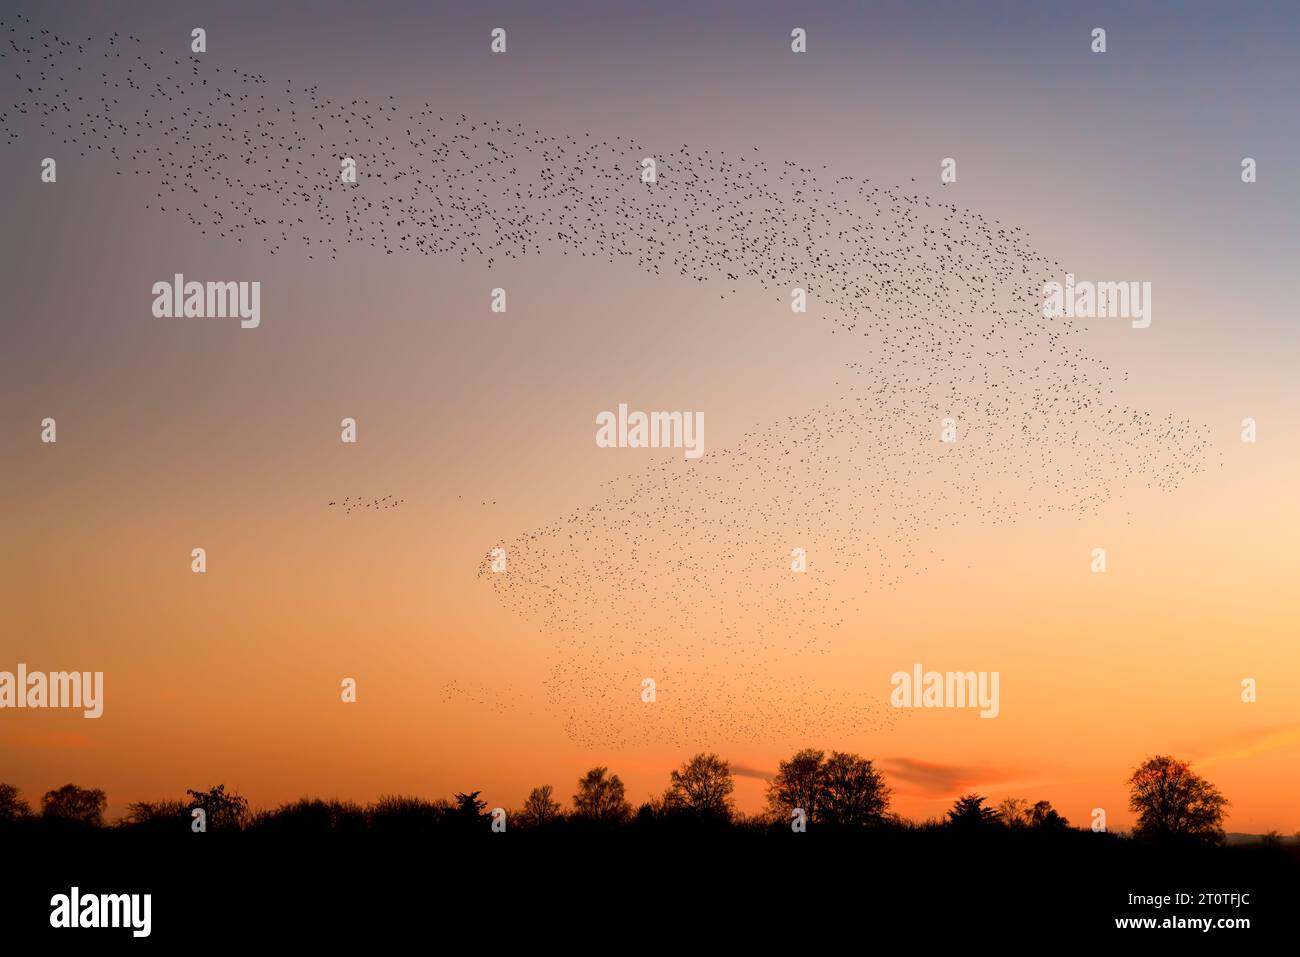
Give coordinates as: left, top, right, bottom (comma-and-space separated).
1128, 754, 1229, 843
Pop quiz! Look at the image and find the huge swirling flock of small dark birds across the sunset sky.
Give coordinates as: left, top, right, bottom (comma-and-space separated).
0, 17, 1209, 745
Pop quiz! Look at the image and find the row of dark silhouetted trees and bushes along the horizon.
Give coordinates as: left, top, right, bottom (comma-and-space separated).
0, 748, 1258, 843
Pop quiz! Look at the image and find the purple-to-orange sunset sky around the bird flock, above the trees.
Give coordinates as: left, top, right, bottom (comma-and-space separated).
0, 3, 1300, 832
